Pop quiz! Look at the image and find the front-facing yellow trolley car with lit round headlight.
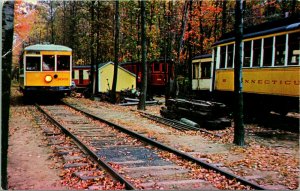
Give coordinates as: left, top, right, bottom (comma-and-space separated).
19, 44, 72, 97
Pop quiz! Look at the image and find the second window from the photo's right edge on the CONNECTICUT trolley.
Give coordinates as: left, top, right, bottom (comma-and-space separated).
275, 35, 286, 66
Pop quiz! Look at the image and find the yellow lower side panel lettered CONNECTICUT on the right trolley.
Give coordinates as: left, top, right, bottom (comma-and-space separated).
215, 67, 300, 97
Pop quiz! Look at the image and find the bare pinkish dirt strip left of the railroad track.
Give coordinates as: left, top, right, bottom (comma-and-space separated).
8, 88, 67, 190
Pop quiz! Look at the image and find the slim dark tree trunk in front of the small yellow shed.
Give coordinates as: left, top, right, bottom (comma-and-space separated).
111, 0, 120, 103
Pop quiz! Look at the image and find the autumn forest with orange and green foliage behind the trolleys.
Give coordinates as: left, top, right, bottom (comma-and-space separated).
13, 0, 300, 82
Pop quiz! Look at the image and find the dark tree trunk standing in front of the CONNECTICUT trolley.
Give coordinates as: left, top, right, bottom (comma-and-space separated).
233, 0, 245, 146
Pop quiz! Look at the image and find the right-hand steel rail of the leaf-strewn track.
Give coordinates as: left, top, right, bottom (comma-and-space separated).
63, 102, 266, 190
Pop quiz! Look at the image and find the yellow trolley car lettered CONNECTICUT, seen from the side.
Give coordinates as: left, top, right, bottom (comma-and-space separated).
212, 19, 300, 113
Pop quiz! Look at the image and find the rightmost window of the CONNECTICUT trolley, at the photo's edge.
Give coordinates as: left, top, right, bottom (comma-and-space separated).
288, 33, 300, 65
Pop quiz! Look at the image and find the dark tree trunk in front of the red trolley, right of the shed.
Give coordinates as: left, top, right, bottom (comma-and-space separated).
138, 1, 148, 110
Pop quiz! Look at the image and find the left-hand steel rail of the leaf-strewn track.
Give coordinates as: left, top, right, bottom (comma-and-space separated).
35, 104, 136, 190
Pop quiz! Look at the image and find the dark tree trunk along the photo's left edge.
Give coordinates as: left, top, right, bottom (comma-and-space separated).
0, 1, 14, 190
